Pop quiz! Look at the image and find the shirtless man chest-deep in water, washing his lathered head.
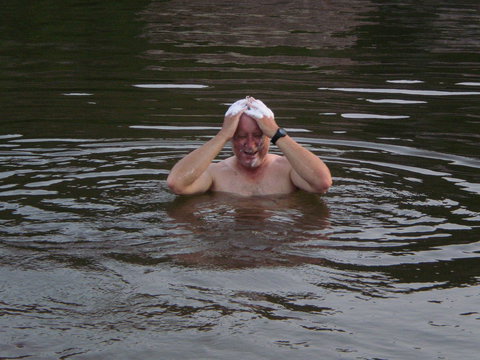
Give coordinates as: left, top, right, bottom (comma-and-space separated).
167, 96, 332, 196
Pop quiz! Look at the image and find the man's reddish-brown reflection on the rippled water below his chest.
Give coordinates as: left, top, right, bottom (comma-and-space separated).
167, 192, 329, 269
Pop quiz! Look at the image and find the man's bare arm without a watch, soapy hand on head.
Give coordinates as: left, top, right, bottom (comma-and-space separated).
167, 102, 246, 195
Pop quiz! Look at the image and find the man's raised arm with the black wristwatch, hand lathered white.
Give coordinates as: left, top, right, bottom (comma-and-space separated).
245, 98, 332, 193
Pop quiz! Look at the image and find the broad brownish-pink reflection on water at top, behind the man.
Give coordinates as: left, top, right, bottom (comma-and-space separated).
141, 0, 372, 50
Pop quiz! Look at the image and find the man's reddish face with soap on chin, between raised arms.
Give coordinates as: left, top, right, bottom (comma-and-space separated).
232, 114, 269, 169
